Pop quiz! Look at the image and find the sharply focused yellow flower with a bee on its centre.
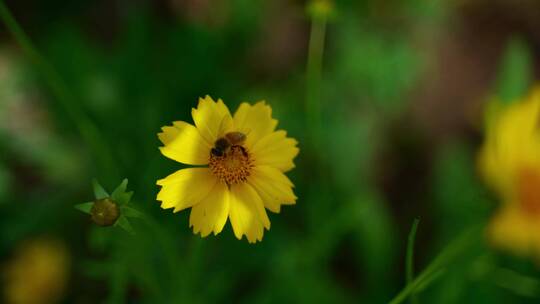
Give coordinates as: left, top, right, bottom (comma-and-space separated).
157, 96, 299, 243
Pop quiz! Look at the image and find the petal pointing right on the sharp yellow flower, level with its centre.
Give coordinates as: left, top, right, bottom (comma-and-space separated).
250, 130, 300, 172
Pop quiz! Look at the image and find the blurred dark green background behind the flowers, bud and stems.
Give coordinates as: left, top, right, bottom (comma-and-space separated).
0, 0, 540, 304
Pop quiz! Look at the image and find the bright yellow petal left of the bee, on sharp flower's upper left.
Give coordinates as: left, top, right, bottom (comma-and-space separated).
158, 121, 211, 165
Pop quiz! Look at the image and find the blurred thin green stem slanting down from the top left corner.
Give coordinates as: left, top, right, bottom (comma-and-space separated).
0, 0, 115, 176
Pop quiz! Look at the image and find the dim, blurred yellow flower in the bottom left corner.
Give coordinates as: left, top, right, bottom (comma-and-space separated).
3, 239, 69, 304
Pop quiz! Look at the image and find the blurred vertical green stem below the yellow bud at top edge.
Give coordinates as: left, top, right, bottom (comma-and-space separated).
305, 16, 326, 145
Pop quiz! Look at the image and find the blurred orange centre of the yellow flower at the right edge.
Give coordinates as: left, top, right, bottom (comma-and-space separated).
517, 168, 540, 216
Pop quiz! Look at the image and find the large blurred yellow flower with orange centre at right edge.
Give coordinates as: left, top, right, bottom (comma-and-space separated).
479, 88, 540, 261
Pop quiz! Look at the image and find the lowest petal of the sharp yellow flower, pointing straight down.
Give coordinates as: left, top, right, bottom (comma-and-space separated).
229, 183, 270, 243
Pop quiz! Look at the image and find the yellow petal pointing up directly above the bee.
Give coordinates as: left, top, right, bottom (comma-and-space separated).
191, 95, 232, 146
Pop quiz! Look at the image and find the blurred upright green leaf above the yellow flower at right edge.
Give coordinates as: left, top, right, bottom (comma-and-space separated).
496, 38, 533, 103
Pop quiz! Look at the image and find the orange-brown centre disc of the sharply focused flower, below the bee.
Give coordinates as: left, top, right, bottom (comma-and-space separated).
209, 145, 253, 185
